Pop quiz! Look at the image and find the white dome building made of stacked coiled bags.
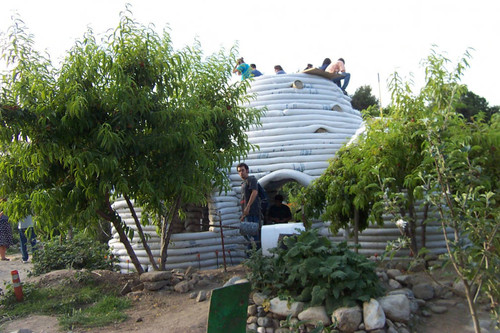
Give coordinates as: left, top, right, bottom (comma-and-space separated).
109, 73, 454, 272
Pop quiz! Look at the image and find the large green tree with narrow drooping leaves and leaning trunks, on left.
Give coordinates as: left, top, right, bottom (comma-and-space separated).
0, 12, 260, 272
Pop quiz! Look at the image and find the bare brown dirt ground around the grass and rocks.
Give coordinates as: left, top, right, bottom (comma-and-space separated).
0, 252, 492, 333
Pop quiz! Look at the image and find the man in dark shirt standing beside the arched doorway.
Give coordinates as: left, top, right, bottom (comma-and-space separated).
236, 163, 260, 249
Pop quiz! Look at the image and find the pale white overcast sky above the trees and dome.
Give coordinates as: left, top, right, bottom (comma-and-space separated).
0, 0, 500, 106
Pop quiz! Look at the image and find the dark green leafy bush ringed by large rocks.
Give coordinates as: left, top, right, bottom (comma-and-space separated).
245, 230, 382, 313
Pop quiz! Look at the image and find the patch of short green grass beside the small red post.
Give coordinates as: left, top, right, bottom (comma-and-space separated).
0, 274, 130, 329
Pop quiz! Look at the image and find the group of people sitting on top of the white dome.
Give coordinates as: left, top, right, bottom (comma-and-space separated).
233, 58, 351, 94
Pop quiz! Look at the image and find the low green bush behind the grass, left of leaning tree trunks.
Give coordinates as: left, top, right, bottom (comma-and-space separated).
33, 234, 114, 275
